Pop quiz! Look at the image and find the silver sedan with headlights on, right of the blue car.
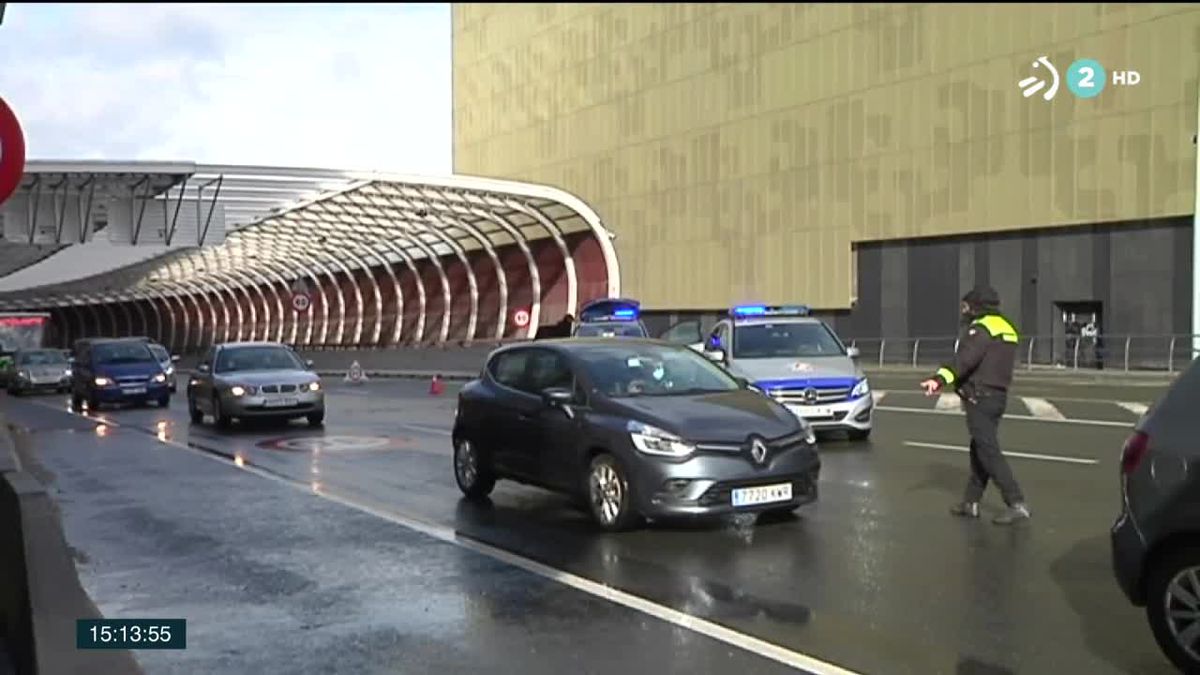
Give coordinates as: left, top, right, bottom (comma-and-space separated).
187, 342, 325, 428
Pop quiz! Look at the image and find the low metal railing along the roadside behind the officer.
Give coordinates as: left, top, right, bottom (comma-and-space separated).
848, 334, 1200, 372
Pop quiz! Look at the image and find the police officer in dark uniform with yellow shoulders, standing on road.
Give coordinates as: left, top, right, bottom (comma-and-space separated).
920, 286, 1030, 525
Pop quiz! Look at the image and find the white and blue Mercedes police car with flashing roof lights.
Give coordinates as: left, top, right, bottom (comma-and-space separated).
691, 305, 874, 441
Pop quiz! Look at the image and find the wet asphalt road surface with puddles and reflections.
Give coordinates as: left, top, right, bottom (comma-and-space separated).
4, 375, 1172, 674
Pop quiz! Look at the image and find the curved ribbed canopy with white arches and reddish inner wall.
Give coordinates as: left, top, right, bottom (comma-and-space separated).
0, 162, 620, 352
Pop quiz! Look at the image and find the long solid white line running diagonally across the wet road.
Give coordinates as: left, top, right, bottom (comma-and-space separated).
21, 396, 859, 675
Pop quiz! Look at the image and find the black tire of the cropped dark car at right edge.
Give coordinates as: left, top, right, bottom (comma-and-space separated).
1146, 544, 1200, 673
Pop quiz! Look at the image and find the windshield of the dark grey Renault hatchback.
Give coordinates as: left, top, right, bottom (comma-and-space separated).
575, 340, 739, 399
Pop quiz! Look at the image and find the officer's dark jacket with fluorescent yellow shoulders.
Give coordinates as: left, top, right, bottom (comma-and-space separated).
934, 312, 1020, 398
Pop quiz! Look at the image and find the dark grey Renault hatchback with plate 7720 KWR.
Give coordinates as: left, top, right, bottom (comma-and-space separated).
452, 338, 821, 530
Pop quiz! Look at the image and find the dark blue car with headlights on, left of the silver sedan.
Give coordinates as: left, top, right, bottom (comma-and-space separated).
71, 338, 170, 411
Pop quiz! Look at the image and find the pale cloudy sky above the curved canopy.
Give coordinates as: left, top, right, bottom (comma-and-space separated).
0, 2, 452, 174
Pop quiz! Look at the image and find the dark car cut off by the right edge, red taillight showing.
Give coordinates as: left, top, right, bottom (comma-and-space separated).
1111, 360, 1200, 673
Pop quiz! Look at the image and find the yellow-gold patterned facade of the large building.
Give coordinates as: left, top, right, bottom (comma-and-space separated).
454, 4, 1200, 310
